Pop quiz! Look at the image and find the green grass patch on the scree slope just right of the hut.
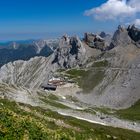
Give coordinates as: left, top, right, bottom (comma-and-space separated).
62, 60, 109, 93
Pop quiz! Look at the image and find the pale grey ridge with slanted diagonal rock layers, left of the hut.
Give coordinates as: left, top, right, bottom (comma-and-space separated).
0, 57, 53, 88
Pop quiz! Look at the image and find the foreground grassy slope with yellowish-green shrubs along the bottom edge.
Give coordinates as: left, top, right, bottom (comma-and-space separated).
0, 99, 140, 140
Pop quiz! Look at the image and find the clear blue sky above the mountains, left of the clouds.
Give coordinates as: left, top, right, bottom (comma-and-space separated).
0, 0, 139, 40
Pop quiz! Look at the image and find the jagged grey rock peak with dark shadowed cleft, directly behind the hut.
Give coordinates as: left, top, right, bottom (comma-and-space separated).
52, 36, 87, 68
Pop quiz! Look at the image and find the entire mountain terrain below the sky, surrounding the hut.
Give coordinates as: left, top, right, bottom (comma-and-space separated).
0, 25, 140, 140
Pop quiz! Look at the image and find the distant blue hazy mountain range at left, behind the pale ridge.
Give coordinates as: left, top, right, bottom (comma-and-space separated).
0, 39, 59, 67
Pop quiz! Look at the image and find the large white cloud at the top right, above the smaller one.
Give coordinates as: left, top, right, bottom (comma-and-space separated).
85, 0, 140, 20
